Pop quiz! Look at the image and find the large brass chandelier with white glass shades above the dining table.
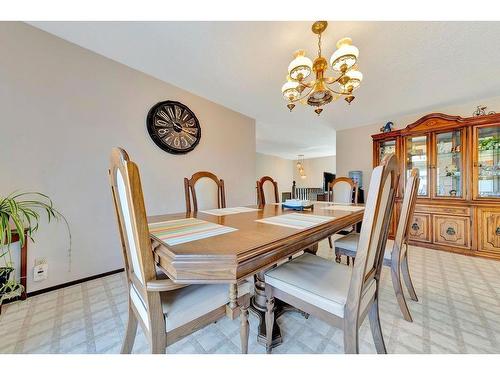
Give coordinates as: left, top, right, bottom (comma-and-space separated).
281, 21, 363, 115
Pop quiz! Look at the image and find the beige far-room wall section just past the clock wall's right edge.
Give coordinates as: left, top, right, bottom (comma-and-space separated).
255, 152, 295, 199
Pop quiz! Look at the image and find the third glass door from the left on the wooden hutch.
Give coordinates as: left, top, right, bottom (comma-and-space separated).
433, 130, 463, 198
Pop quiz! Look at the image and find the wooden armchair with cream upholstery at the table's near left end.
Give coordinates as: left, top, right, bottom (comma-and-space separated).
109, 148, 250, 353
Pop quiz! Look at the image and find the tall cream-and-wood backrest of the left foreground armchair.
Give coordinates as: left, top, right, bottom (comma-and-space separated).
109, 148, 156, 327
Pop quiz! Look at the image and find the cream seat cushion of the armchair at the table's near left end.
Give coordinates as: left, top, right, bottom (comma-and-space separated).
160, 282, 250, 332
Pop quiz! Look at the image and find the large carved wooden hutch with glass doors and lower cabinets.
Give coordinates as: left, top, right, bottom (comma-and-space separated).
372, 113, 500, 259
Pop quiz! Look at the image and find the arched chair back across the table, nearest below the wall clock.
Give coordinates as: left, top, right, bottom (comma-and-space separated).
184, 171, 226, 212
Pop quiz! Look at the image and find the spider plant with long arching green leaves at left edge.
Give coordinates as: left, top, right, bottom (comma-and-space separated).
0, 192, 71, 306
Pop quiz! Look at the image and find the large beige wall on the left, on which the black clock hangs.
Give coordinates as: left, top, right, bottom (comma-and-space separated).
0, 22, 255, 291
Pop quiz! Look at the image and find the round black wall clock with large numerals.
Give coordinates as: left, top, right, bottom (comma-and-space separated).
147, 100, 201, 154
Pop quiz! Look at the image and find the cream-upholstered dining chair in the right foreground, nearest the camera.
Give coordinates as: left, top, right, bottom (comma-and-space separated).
265, 155, 398, 353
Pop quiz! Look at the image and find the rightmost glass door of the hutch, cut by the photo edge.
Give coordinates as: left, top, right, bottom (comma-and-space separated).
476, 126, 500, 198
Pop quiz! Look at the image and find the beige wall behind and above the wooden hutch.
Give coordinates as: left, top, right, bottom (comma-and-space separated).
337, 96, 500, 192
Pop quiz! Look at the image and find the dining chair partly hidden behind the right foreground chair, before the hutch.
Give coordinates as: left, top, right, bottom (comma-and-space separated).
335, 168, 420, 322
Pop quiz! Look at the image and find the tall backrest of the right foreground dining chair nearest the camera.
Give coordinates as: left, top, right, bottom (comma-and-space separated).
346, 155, 399, 319
